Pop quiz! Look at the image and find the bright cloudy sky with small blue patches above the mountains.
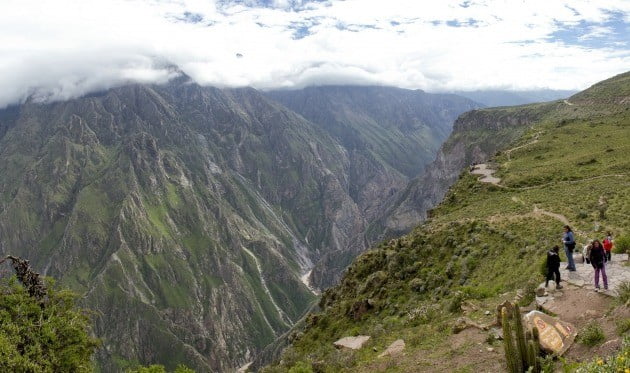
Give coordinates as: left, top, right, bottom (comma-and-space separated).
0, 0, 630, 108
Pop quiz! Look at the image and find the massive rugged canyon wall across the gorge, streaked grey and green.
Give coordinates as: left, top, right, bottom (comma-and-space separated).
0, 80, 474, 371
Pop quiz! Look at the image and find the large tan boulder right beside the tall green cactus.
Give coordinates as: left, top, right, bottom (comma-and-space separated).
523, 311, 577, 356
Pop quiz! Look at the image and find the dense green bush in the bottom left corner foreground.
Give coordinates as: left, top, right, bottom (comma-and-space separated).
0, 277, 98, 372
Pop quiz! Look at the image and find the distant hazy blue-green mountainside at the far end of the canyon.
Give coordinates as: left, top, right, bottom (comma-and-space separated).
267, 86, 479, 288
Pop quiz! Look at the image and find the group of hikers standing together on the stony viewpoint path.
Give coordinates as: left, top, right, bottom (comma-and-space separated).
545, 225, 613, 291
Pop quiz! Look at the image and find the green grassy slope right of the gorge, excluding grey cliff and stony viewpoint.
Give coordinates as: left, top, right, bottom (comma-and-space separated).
266, 73, 630, 372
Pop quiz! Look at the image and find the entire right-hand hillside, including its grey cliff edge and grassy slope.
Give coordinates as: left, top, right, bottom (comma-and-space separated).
258, 72, 630, 373
